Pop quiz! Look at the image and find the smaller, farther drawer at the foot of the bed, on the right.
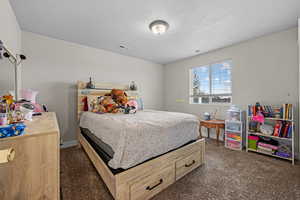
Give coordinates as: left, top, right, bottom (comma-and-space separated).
176, 151, 202, 180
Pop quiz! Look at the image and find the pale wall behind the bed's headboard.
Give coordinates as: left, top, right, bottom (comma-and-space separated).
22, 32, 163, 141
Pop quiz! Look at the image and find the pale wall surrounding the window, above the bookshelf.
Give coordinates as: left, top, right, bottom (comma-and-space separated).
164, 28, 299, 153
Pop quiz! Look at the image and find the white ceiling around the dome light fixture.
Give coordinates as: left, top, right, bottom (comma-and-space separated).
10, 0, 300, 64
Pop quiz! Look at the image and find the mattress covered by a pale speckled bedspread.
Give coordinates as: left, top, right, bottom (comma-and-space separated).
80, 110, 199, 169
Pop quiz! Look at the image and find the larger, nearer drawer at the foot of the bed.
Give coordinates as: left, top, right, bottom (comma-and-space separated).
130, 165, 175, 200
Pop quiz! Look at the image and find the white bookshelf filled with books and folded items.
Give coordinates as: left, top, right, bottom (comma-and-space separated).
246, 103, 295, 164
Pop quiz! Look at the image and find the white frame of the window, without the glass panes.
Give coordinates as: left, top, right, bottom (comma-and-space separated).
189, 58, 233, 106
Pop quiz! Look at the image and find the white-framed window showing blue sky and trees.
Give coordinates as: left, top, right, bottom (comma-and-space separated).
190, 60, 232, 104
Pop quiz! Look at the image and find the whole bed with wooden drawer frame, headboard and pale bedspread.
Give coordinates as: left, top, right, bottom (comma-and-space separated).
77, 82, 205, 200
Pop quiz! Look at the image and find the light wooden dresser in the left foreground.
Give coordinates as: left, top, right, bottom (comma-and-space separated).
0, 112, 59, 200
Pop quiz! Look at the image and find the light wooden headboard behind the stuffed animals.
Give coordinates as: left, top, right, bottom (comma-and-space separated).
77, 81, 139, 119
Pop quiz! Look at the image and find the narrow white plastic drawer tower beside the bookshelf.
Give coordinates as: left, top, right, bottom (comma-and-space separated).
225, 105, 245, 151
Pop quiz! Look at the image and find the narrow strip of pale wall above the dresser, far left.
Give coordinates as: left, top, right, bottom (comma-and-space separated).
0, 0, 21, 95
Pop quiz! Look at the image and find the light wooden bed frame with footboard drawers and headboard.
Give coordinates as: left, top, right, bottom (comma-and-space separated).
77, 81, 205, 200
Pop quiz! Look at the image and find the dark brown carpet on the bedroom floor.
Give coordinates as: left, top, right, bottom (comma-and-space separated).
60, 140, 300, 200
